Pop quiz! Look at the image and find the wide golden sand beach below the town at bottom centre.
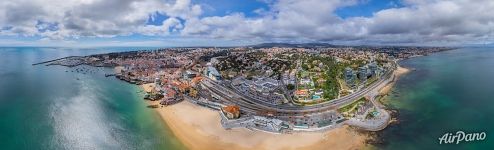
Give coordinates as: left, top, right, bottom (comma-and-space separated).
151, 101, 368, 150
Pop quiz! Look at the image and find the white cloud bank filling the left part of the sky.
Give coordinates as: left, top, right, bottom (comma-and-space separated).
0, 0, 201, 39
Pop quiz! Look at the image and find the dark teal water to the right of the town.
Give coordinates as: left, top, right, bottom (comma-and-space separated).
377, 48, 494, 149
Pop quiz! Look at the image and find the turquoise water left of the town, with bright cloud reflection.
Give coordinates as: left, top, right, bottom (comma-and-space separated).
0, 48, 184, 150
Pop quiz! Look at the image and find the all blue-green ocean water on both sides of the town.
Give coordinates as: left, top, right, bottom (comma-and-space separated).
0, 47, 494, 150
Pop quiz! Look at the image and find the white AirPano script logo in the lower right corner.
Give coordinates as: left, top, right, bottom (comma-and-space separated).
439, 131, 487, 144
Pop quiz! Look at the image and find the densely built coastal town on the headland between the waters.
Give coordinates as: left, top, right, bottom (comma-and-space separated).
37, 46, 456, 133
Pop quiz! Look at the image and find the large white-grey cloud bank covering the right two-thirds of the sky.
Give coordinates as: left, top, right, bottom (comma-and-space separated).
179, 0, 494, 45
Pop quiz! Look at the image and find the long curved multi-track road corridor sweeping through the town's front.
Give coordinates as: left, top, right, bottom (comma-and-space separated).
203, 66, 394, 115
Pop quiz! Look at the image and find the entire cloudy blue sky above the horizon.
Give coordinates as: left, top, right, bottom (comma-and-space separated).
0, 0, 494, 46
